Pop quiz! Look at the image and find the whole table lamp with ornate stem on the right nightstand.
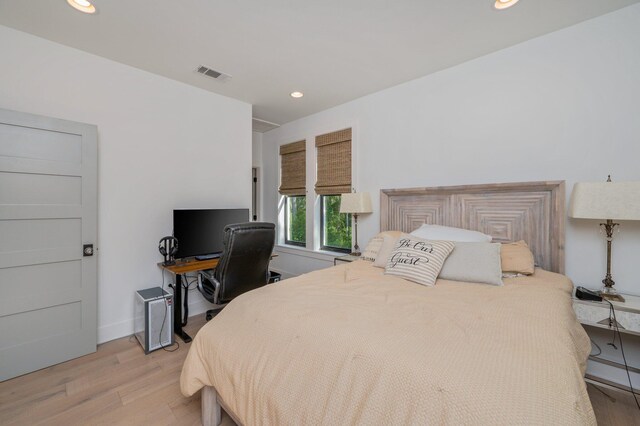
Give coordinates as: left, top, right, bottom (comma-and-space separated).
569, 176, 640, 302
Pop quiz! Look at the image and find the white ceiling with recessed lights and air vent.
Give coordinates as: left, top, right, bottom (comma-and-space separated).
0, 0, 640, 124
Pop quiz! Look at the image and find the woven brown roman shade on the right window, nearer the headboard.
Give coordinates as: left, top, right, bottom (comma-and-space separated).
316, 129, 351, 195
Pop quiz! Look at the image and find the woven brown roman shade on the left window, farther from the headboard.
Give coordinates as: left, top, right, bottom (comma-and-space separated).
278, 140, 307, 195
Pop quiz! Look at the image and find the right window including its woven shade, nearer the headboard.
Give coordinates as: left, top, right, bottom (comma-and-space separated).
315, 129, 351, 253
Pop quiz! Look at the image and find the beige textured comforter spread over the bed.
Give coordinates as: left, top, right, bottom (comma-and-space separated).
181, 261, 595, 425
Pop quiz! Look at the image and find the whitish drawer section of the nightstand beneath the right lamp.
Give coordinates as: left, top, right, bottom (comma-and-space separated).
573, 294, 640, 336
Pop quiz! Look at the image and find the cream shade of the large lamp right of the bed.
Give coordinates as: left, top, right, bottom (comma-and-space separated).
569, 182, 640, 220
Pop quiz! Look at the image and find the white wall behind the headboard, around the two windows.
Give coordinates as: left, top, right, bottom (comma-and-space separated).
263, 5, 640, 295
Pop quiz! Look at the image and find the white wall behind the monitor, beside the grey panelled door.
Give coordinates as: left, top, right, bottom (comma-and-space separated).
0, 26, 252, 342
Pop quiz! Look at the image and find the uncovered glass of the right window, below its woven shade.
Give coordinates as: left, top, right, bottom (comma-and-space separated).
320, 194, 351, 253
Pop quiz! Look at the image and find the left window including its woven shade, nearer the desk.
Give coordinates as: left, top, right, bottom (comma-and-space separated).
278, 140, 307, 247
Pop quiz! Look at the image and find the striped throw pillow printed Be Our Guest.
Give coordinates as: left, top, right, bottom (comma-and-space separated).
385, 235, 455, 286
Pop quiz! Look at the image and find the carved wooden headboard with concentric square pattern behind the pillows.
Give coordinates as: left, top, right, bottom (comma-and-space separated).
380, 181, 565, 273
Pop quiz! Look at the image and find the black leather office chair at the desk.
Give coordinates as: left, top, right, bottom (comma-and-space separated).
198, 222, 276, 321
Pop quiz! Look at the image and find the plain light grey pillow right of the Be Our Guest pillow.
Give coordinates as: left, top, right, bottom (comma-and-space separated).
439, 243, 502, 285
